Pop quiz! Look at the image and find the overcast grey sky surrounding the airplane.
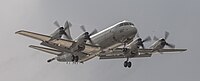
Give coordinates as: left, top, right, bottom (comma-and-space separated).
0, 0, 200, 81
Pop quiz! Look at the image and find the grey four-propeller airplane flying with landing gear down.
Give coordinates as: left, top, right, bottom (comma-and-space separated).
15, 20, 187, 68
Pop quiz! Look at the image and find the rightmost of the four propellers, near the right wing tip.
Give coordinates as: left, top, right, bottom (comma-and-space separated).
154, 32, 175, 48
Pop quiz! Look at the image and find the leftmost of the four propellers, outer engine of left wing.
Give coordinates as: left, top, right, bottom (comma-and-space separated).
54, 21, 72, 39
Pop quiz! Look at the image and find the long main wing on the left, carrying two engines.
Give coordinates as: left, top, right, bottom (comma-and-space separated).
16, 30, 100, 54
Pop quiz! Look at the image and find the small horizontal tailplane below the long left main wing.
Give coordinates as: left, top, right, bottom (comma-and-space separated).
29, 45, 62, 55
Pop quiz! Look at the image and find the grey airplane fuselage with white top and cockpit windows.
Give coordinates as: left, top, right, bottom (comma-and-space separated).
91, 21, 137, 50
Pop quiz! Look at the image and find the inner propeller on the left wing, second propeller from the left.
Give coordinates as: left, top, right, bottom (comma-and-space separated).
80, 25, 98, 45
